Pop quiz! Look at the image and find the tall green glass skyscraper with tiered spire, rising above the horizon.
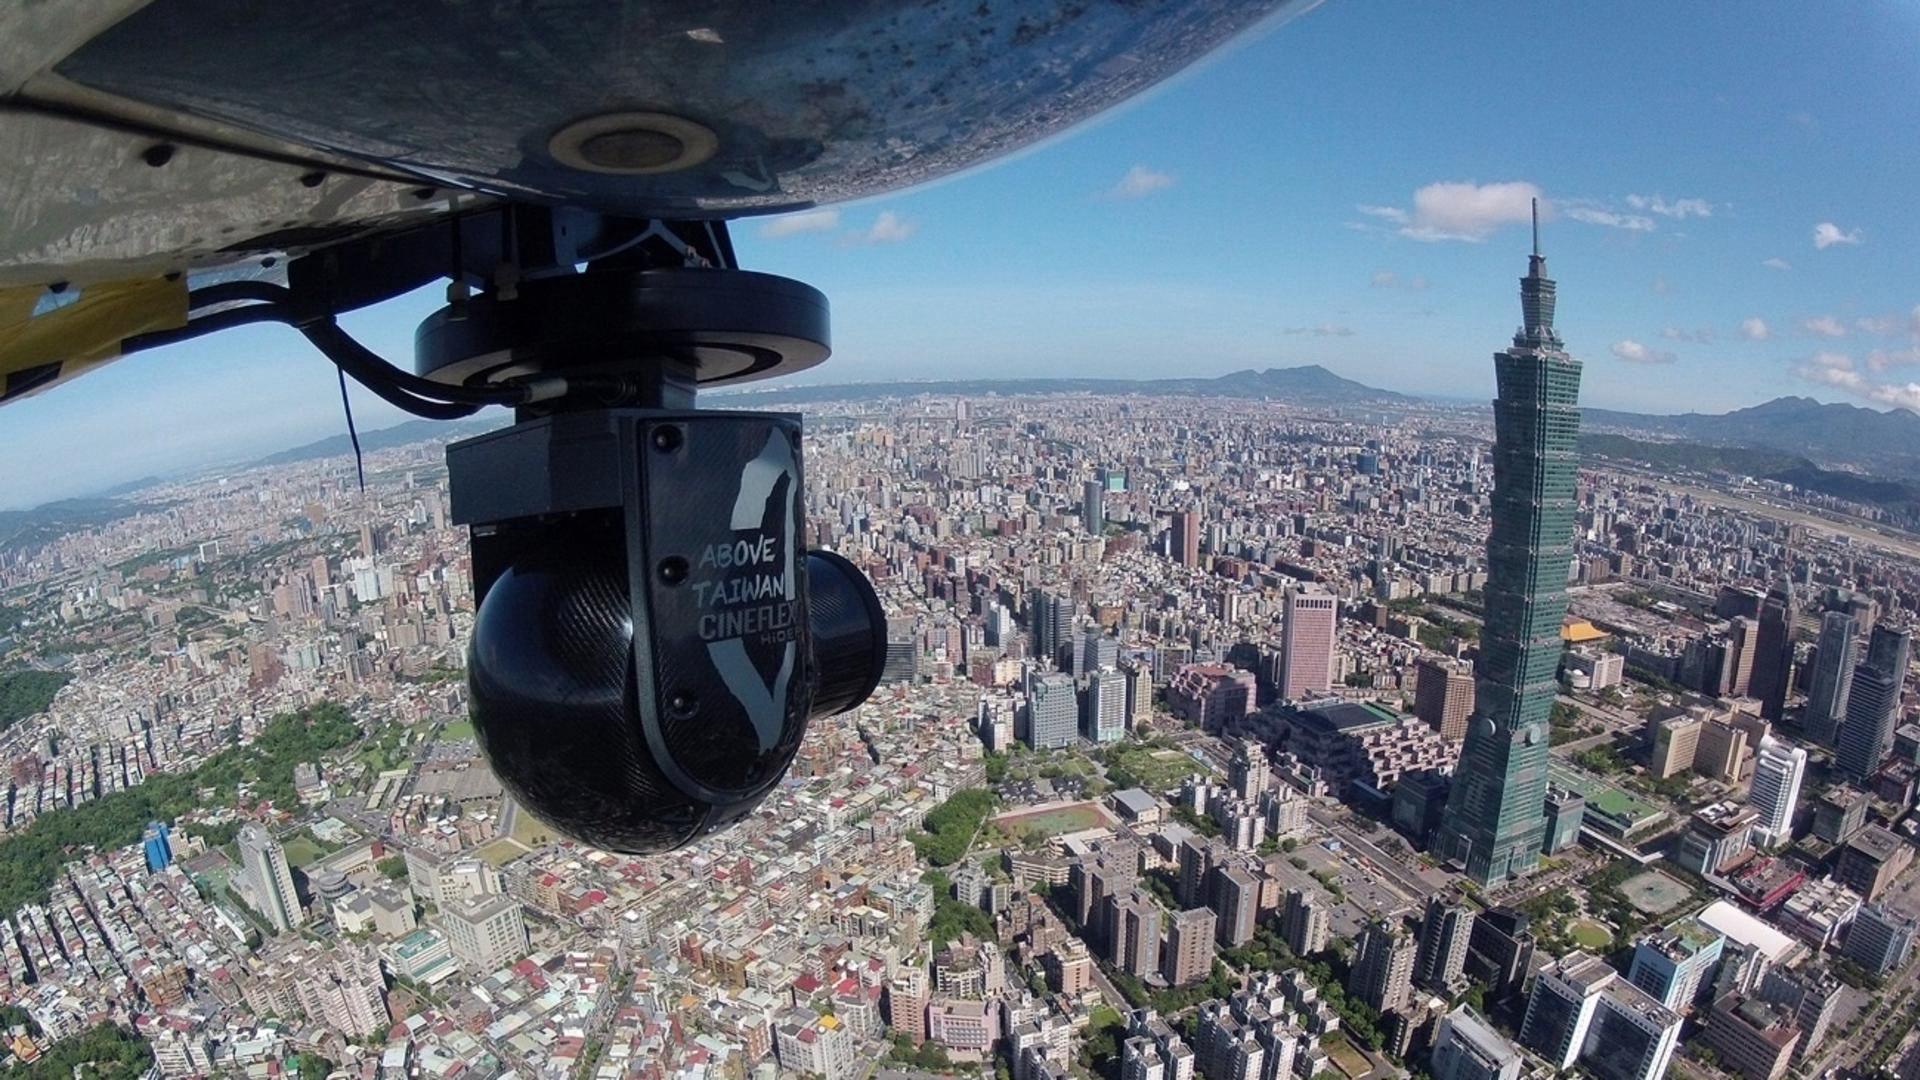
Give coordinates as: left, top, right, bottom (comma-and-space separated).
1438, 205, 1580, 884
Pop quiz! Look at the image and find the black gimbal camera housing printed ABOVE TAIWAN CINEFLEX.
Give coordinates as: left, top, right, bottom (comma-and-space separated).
447, 409, 885, 851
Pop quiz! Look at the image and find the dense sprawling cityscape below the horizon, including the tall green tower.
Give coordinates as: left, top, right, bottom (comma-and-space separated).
0, 223, 1920, 1080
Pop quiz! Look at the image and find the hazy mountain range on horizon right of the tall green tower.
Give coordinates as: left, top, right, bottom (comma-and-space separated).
1582, 398, 1920, 477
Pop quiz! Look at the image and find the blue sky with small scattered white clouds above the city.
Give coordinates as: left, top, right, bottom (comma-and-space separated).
0, 0, 1920, 505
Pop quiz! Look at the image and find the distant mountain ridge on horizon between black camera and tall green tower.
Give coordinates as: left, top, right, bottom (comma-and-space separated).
708, 363, 1415, 405
